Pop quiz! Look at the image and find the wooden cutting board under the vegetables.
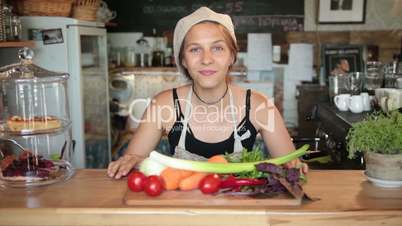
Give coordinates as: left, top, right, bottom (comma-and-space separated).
124, 190, 301, 207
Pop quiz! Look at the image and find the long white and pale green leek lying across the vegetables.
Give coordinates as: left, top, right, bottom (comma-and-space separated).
140, 144, 309, 175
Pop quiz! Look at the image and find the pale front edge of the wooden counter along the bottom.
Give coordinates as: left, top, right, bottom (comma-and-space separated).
0, 208, 402, 226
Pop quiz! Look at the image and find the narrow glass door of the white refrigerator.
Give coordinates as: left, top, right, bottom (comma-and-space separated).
80, 35, 111, 168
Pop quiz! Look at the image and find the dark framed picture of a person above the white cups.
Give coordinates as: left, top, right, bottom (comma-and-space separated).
321, 45, 364, 81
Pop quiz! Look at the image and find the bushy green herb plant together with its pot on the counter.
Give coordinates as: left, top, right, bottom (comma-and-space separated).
346, 111, 402, 182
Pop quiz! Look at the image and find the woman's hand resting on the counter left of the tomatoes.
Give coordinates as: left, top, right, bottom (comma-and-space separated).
107, 154, 144, 179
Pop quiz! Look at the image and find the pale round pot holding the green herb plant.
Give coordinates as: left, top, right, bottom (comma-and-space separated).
364, 152, 402, 181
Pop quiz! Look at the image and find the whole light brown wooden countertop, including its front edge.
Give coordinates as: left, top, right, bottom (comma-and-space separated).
0, 170, 402, 226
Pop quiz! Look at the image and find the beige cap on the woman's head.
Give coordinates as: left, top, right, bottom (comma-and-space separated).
173, 6, 236, 74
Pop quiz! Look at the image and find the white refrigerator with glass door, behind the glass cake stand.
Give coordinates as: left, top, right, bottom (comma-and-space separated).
21, 16, 111, 168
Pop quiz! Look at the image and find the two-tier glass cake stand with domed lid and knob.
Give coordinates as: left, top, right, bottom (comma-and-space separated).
0, 48, 74, 187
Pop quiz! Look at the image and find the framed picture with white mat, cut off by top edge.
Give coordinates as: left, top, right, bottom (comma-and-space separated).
318, 0, 366, 24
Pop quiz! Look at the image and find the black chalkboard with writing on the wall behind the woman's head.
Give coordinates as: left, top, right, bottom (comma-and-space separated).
107, 0, 304, 33
